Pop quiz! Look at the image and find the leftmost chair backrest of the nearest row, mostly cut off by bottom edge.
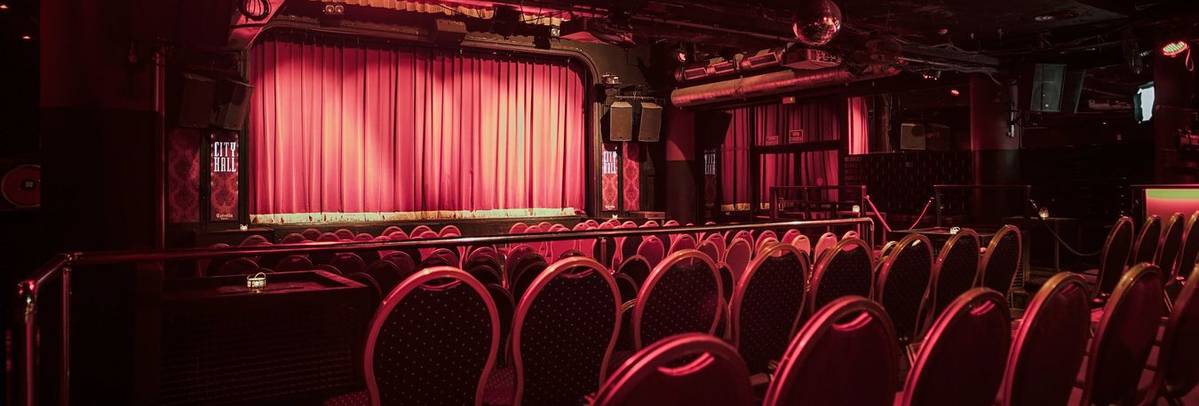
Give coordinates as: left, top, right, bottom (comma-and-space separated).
591, 333, 754, 406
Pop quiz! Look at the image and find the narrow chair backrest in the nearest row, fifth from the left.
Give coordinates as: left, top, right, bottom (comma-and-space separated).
1081, 262, 1165, 405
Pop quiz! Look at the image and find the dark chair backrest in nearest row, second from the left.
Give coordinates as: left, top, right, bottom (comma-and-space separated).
763, 296, 900, 406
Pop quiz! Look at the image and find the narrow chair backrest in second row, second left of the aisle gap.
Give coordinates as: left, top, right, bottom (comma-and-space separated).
917, 229, 978, 334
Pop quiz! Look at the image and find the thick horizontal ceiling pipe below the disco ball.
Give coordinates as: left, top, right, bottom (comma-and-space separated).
670, 68, 898, 108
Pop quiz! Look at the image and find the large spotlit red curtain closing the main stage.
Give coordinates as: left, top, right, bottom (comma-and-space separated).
248, 40, 586, 222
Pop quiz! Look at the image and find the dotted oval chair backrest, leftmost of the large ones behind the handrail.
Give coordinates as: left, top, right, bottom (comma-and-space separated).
363, 267, 500, 405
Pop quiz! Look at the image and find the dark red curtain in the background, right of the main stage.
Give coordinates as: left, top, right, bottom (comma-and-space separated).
721, 102, 845, 211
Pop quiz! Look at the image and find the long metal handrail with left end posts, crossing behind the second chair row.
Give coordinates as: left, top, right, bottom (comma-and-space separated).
17, 217, 874, 406
